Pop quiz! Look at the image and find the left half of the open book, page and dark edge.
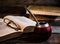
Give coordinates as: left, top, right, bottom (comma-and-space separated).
0, 19, 21, 41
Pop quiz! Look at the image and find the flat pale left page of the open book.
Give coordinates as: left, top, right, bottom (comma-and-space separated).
0, 19, 17, 37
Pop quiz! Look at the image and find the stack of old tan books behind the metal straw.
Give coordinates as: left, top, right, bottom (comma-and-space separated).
26, 5, 60, 20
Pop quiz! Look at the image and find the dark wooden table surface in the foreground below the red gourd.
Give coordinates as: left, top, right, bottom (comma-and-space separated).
0, 34, 60, 44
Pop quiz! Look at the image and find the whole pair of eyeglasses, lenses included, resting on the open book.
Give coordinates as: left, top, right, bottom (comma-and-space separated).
4, 18, 20, 31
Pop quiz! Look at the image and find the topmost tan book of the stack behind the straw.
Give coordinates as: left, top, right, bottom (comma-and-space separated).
27, 5, 60, 16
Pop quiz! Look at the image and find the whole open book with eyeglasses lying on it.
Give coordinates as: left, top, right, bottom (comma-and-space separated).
0, 15, 36, 41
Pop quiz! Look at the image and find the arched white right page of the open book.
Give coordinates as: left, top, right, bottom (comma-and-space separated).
3, 15, 36, 32
